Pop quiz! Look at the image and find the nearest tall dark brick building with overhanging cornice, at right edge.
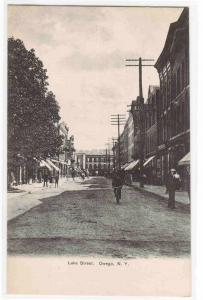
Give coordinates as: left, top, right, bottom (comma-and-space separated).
155, 8, 190, 183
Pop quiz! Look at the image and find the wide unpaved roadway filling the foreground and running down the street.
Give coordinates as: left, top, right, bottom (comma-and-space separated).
8, 177, 190, 258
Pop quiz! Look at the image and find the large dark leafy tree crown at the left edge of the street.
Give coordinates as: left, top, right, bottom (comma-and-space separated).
8, 38, 62, 185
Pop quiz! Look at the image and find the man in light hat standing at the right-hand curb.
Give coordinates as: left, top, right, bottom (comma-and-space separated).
166, 169, 180, 209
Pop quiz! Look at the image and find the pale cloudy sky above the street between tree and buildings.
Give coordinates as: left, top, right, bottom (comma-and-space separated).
8, 5, 183, 149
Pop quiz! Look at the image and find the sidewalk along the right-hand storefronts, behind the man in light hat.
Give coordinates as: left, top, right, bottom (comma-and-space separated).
131, 182, 190, 205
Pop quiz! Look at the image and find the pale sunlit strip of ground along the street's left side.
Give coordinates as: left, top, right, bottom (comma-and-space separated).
7, 178, 88, 221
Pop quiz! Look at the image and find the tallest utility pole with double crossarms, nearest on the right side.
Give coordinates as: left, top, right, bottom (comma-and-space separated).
126, 57, 154, 187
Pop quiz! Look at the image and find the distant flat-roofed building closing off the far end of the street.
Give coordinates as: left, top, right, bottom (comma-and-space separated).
75, 151, 113, 176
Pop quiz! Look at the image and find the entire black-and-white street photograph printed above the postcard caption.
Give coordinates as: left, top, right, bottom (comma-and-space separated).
7, 5, 192, 259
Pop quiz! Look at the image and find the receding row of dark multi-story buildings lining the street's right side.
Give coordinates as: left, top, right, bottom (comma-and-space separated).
111, 8, 190, 188
